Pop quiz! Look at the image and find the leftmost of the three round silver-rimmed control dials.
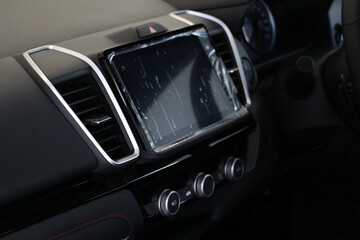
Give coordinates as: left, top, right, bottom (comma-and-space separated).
158, 189, 180, 217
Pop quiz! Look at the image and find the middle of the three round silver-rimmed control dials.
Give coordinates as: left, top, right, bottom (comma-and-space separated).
193, 172, 215, 198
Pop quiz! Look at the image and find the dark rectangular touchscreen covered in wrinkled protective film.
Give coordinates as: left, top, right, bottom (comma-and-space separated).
105, 29, 240, 150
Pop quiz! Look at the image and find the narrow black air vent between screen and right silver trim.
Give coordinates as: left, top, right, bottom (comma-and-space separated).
211, 32, 246, 102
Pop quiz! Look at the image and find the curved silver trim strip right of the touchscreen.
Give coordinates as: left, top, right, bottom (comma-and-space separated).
169, 10, 251, 108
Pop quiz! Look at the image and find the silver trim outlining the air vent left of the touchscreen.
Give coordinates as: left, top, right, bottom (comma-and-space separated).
23, 45, 140, 166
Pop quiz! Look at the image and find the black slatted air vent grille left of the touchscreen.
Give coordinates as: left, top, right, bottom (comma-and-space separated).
55, 74, 130, 160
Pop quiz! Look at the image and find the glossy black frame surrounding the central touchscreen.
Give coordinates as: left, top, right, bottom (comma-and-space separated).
103, 24, 249, 154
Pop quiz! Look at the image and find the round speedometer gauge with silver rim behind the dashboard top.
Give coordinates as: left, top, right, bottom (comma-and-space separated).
242, 0, 276, 55
